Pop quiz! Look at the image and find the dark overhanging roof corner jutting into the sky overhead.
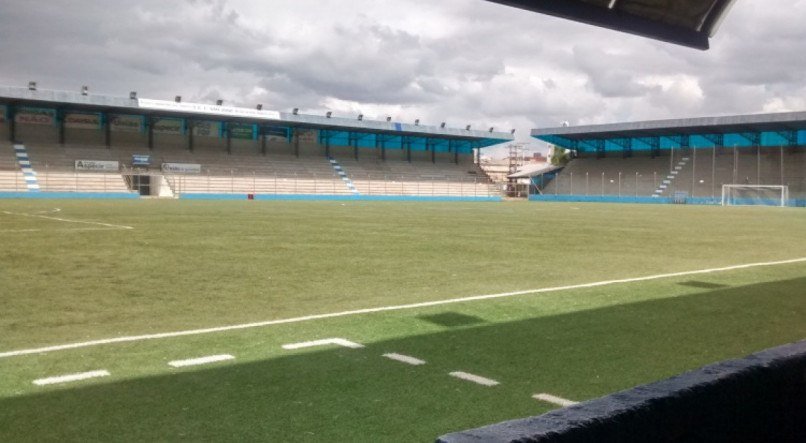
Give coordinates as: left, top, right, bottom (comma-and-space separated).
488, 0, 735, 49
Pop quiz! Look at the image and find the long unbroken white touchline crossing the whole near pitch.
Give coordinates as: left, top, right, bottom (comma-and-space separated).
0, 257, 806, 358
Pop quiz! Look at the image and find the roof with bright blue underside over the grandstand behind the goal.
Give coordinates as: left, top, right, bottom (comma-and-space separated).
532, 112, 806, 152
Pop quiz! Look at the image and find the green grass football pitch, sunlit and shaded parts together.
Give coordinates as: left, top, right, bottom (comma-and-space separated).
0, 200, 806, 442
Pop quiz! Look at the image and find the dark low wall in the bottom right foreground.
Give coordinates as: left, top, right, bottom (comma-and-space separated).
437, 341, 806, 443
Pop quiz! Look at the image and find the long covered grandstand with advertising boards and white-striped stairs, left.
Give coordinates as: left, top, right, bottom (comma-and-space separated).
0, 82, 513, 201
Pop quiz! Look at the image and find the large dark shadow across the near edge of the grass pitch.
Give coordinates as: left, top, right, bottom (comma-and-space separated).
0, 278, 806, 441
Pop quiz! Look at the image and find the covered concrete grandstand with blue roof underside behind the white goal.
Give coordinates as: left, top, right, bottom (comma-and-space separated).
530, 112, 806, 206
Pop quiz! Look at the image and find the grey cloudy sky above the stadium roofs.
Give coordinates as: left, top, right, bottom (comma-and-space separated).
0, 0, 806, 153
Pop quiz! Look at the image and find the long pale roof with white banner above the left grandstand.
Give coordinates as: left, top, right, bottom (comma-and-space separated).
0, 86, 514, 148
